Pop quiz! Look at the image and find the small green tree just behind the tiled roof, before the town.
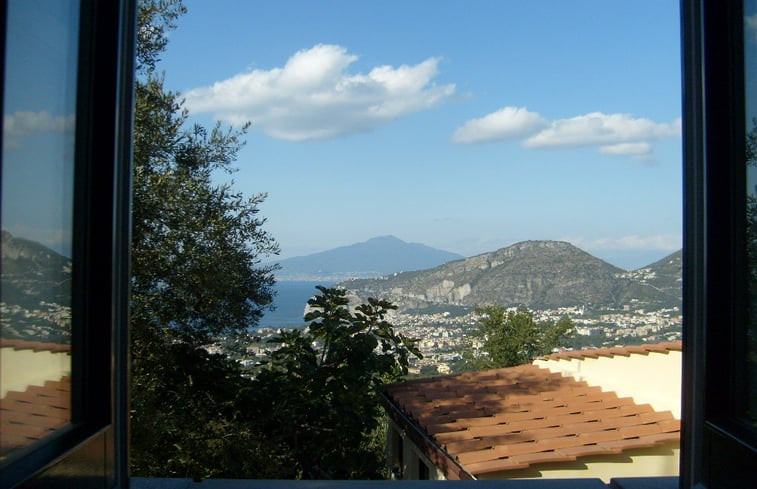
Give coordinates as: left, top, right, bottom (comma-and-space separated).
463, 305, 573, 370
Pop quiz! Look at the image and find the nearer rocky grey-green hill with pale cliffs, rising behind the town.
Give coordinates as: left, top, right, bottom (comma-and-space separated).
342, 241, 680, 310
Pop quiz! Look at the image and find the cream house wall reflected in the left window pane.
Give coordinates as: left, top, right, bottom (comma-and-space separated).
0, 348, 71, 398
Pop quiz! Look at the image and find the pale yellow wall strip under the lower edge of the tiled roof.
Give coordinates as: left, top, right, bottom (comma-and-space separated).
478, 442, 680, 483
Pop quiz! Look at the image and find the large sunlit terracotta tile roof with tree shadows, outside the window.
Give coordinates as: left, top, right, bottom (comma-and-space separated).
385, 365, 680, 478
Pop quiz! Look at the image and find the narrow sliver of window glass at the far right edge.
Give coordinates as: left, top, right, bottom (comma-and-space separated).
740, 0, 757, 425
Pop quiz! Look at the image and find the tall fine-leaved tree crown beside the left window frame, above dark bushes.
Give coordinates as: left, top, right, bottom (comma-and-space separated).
132, 53, 278, 345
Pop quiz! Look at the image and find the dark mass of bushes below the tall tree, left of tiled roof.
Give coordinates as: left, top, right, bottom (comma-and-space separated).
132, 287, 421, 479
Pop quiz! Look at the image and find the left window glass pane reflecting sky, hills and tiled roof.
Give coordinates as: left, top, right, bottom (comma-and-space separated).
0, 0, 79, 460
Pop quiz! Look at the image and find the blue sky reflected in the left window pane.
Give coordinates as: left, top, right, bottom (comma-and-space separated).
0, 1, 79, 256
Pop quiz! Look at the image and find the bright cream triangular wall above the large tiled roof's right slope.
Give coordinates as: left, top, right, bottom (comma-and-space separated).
533, 351, 682, 419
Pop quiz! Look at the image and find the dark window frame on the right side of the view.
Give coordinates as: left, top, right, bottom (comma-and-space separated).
680, 0, 757, 488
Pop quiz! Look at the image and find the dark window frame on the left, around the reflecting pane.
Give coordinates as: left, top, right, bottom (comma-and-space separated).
0, 0, 136, 488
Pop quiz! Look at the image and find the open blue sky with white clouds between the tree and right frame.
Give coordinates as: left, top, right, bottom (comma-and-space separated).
161, 0, 681, 268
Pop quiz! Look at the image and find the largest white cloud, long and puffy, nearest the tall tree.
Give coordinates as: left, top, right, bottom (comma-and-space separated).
185, 44, 455, 141
